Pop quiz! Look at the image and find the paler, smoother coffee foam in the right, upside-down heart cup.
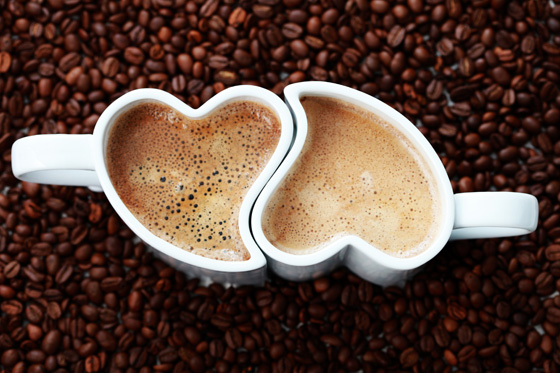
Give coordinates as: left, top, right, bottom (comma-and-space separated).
262, 97, 440, 258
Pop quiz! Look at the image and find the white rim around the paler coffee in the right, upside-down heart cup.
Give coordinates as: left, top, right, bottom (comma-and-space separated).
251, 82, 455, 270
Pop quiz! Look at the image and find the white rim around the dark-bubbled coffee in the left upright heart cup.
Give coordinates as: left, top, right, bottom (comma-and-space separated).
93, 85, 293, 273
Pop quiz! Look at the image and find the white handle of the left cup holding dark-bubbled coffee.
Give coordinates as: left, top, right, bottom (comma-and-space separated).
12, 134, 102, 191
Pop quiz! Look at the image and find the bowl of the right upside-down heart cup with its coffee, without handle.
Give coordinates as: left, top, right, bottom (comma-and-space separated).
252, 82, 454, 283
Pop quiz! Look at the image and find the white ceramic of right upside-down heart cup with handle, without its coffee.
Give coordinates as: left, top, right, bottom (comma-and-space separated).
251, 82, 538, 285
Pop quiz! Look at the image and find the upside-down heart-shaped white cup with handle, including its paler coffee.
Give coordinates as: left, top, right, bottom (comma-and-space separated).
251, 82, 538, 285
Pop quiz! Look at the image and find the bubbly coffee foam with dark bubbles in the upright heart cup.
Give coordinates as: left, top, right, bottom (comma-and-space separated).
107, 101, 281, 261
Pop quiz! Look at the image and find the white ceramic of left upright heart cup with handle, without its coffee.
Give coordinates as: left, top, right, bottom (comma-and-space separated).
12, 86, 294, 284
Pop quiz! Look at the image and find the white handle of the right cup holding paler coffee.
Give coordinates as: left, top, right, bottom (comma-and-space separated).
450, 192, 539, 240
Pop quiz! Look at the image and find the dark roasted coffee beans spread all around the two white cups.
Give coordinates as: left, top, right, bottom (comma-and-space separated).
0, 0, 560, 372
